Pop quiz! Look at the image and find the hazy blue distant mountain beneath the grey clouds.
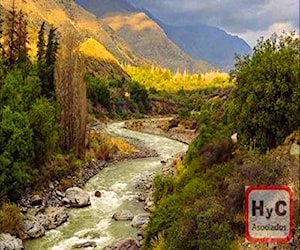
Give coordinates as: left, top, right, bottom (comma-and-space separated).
156, 22, 252, 71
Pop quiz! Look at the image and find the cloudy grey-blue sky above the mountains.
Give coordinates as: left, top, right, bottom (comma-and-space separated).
129, 0, 300, 47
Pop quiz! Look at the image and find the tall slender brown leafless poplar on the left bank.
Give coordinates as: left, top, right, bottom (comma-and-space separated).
55, 32, 87, 157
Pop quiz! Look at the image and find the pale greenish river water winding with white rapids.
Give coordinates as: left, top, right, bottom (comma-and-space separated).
25, 123, 187, 250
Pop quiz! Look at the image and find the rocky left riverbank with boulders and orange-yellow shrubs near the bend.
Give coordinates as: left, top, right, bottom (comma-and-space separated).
0, 123, 157, 249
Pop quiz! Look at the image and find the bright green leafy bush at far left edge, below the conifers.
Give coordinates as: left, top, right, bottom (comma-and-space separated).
0, 107, 34, 199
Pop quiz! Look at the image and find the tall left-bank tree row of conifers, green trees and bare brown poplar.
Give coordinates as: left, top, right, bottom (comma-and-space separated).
0, 1, 86, 202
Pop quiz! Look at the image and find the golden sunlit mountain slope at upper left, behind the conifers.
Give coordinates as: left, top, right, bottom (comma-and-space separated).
0, 0, 149, 79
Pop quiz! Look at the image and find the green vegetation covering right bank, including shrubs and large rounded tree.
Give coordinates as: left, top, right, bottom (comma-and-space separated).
145, 32, 300, 250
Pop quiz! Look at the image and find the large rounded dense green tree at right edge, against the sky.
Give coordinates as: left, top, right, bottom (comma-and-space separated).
229, 34, 300, 151
